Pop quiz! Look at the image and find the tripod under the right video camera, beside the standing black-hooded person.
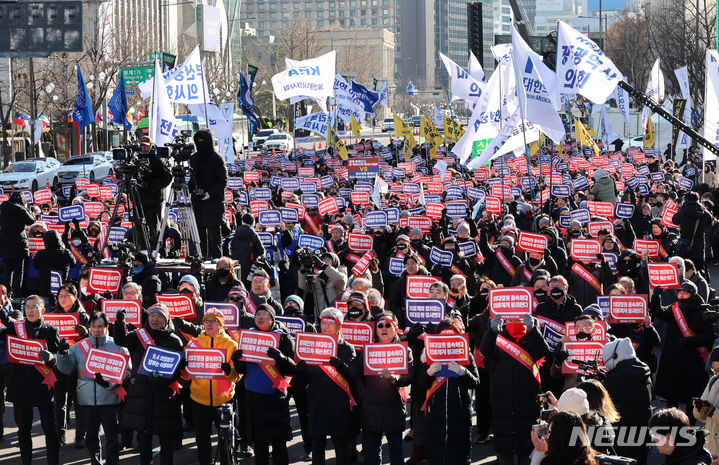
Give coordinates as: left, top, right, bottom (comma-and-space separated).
153, 163, 202, 258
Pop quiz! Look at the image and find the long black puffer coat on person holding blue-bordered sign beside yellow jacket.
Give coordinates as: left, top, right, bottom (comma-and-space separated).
114, 322, 182, 434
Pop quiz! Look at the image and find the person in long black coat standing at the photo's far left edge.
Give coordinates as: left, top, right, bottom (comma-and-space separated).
0, 191, 35, 297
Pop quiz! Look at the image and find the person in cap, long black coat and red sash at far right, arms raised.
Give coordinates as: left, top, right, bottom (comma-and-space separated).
649, 281, 714, 416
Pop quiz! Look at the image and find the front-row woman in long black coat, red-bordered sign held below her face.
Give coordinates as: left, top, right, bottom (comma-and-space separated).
418, 316, 479, 465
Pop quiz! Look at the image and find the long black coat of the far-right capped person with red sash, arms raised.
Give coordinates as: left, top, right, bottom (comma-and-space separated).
651, 294, 714, 402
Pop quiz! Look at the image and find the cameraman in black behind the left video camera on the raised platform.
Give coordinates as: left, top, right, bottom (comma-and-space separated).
138, 136, 172, 247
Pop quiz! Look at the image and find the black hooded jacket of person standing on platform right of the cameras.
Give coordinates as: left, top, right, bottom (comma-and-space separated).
189, 130, 227, 226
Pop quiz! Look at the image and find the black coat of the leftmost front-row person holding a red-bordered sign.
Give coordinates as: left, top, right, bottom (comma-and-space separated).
0, 316, 60, 407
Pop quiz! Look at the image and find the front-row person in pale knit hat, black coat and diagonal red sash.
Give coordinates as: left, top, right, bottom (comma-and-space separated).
297, 307, 361, 465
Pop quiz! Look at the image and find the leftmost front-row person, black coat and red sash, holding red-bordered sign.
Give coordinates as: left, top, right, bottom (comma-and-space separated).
0, 296, 61, 465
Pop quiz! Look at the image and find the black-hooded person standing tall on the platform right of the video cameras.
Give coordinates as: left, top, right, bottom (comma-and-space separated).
189, 129, 227, 258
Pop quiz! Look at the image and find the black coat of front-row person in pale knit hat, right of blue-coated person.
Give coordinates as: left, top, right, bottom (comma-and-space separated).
297, 339, 362, 437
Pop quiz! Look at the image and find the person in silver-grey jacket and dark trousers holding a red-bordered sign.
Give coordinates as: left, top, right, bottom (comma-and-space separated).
47, 312, 130, 465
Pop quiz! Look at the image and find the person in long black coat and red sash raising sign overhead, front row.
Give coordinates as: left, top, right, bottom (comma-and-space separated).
481, 315, 549, 465
